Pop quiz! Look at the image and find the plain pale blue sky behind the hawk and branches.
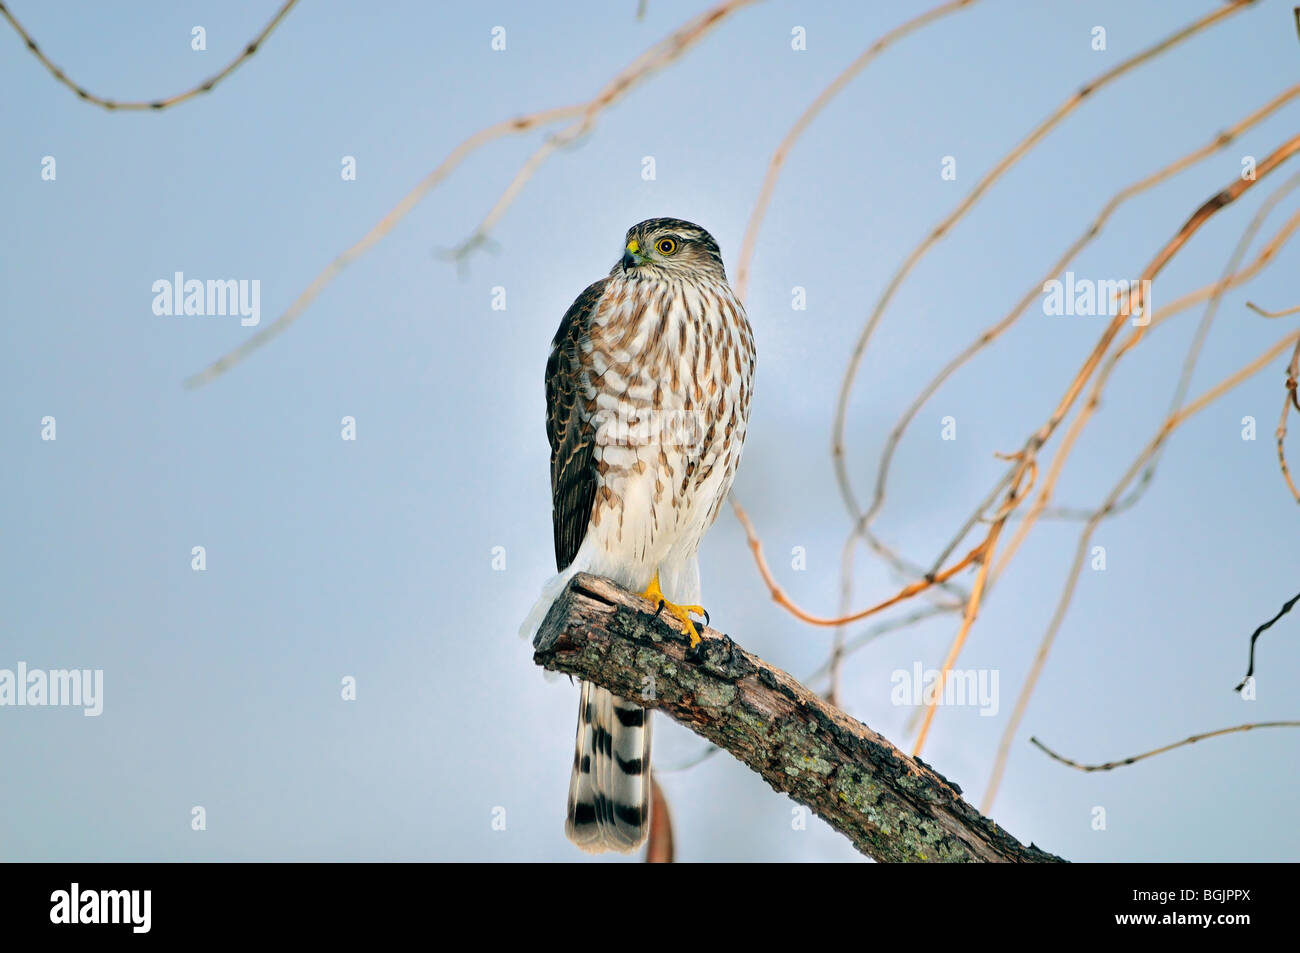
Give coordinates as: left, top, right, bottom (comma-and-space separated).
0, 0, 1300, 861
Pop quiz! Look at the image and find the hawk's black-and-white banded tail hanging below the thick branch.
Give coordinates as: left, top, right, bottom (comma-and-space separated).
564, 681, 651, 853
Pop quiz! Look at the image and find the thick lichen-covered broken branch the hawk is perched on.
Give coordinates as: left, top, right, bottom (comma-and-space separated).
533, 573, 1061, 862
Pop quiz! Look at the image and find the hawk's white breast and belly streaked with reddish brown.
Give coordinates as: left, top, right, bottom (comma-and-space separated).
580, 271, 754, 577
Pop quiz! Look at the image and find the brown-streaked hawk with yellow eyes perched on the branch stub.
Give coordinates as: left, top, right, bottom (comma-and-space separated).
525, 218, 754, 852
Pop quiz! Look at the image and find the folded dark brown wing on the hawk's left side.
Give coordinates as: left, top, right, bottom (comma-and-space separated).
546, 278, 608, 569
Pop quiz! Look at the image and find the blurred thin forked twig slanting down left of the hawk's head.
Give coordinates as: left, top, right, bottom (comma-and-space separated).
186, 0, 755, 387
